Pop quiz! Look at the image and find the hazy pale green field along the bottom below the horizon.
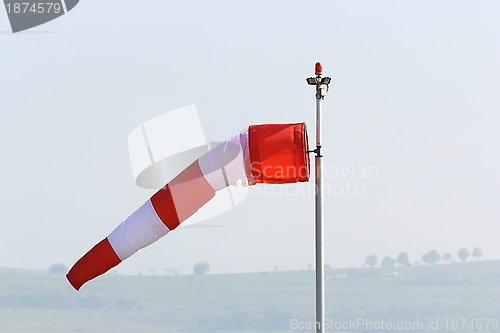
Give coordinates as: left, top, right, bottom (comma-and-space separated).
0, 261, 500, 333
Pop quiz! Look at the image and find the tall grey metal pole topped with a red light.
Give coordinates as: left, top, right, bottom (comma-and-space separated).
306, 62, 331, 333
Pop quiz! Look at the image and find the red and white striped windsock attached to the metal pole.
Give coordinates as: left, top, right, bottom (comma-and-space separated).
66, 123, 309, 290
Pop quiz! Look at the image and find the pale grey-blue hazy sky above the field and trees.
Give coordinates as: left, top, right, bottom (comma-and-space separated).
0, 1, 500, 274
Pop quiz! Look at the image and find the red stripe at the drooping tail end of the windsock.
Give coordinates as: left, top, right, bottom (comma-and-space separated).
66, 238, 121, 290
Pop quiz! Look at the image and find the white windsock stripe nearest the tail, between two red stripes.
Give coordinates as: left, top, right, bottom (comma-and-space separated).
108, 199, 170, 260
